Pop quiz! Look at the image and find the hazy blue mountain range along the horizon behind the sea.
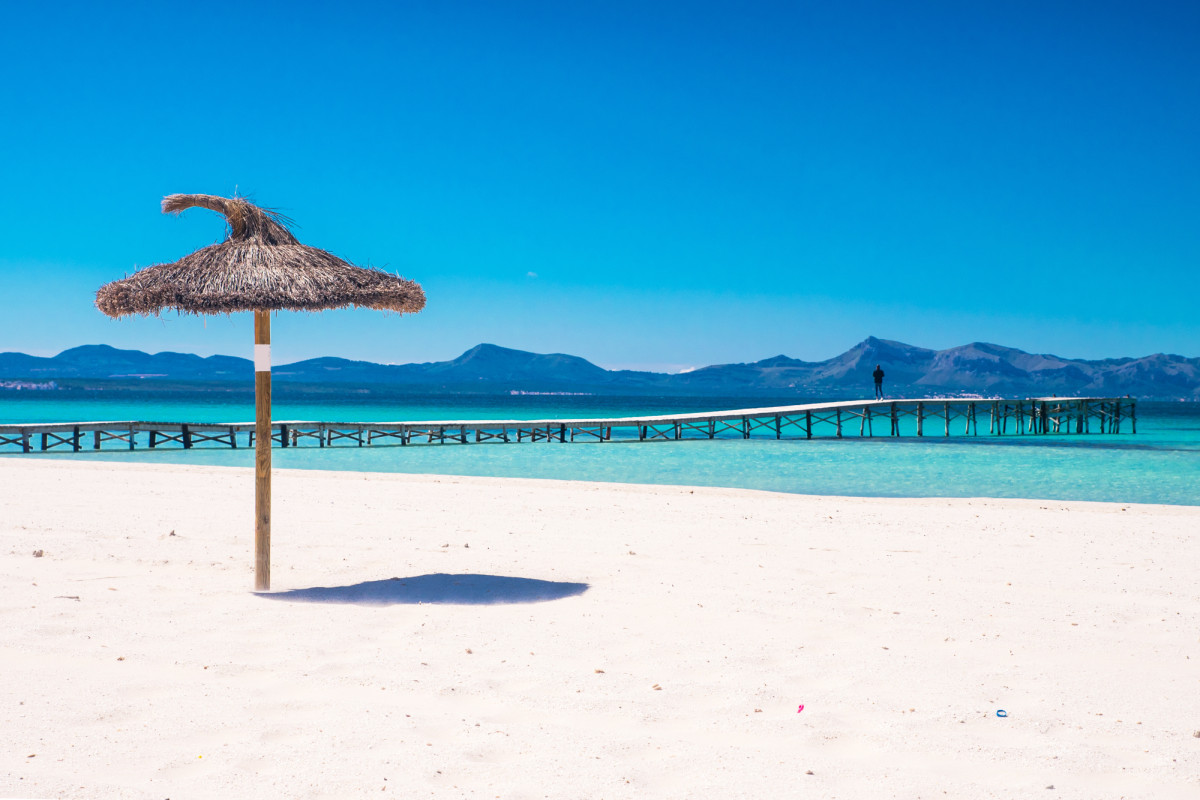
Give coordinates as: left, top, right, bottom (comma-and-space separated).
0, 336, 1200, 401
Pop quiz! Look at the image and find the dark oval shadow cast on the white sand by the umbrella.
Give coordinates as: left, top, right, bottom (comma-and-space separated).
262, 572, 588, 606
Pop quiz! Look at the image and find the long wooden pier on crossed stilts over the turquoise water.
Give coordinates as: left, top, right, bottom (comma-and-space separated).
0, 397, 1138, 453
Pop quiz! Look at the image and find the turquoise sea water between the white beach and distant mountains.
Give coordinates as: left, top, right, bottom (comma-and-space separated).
0, 387, 1200, 505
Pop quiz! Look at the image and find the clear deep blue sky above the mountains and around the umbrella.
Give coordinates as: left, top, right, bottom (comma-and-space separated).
0, 0, 1200, 368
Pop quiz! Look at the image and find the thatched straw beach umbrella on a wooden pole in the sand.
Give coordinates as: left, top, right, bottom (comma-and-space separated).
96, 194, 425, 591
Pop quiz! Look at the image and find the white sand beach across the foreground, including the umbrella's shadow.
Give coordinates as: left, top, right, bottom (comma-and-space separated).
0, 456, 1200, 799
